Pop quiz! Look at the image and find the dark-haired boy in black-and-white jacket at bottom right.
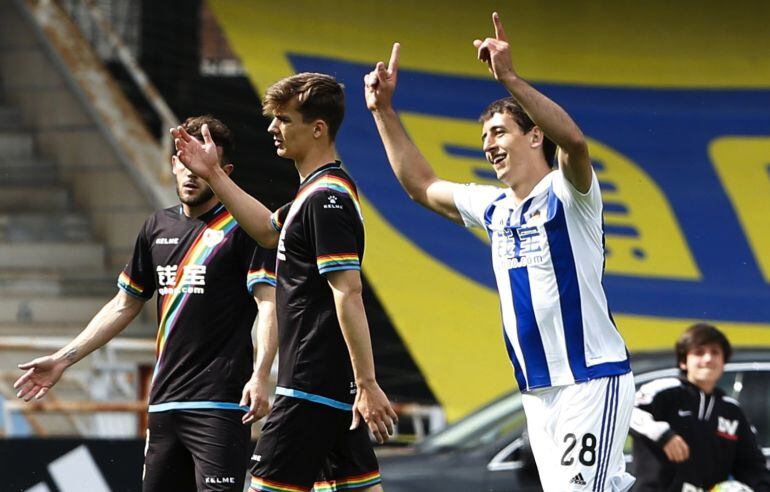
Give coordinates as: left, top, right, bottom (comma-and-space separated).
631, 323, 770, 492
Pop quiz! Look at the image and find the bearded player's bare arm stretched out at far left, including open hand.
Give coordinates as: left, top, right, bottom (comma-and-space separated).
13, 290, 144, 401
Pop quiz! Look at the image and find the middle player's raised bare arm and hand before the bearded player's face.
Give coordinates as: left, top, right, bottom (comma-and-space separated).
171, 125, 278, 249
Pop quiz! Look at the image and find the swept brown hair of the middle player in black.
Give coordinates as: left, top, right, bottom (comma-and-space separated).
262, 72, 345, 141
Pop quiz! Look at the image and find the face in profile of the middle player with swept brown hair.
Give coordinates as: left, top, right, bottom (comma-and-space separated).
267, 97, 316, 161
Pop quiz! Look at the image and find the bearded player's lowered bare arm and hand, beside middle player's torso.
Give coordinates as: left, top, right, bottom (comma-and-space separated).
241, 284, 278, 424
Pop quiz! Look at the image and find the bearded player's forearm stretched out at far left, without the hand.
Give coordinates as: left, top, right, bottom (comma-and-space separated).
53, 292, 144, 366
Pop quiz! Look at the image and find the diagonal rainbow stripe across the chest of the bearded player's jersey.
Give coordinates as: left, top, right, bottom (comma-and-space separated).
152, 207, 238, 381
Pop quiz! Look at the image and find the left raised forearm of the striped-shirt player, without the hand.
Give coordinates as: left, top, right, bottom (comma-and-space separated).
372, 107, 437, 207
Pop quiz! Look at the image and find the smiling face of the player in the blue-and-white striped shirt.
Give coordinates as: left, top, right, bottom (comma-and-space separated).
481, 112, 547, 186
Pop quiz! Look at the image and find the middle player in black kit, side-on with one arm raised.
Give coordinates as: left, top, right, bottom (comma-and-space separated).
172, 73, 396, 492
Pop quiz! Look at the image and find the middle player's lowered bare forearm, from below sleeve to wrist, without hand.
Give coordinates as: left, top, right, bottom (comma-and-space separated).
334, 289, 376, 386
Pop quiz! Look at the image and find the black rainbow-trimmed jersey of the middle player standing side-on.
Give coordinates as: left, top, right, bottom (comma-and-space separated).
272, 162, 364, 410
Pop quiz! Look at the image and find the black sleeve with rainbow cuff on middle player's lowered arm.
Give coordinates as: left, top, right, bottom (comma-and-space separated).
306, 189, 364, 275
